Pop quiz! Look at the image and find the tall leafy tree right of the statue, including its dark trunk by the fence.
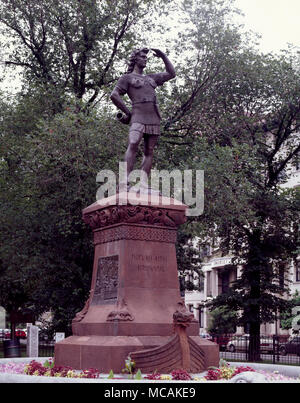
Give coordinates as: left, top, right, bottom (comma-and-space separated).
155, 1, 300, 360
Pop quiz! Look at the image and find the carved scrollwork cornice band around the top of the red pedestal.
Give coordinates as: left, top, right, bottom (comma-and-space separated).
83, 205, 186, 229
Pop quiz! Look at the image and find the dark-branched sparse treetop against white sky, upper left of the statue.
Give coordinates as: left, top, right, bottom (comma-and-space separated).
0, 0, 166, 106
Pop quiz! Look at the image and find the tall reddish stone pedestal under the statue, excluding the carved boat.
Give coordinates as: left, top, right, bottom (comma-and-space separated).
55, 193, 219, 373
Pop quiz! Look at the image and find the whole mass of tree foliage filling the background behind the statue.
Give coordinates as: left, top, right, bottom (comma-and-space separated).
0, 0, 300, 346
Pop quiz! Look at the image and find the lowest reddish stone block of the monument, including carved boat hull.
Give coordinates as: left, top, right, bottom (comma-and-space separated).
55, 335, 219, 374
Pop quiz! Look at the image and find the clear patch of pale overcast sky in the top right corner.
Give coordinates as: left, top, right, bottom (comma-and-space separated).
235, 0, 300, 52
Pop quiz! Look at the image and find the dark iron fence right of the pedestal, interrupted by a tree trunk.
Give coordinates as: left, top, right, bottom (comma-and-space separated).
210, 334, 300, 365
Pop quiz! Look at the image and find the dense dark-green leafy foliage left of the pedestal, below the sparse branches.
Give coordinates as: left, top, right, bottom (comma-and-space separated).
0, 98, 125, 333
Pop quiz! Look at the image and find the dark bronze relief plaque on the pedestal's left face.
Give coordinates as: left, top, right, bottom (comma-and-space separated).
92, 255, 119, 305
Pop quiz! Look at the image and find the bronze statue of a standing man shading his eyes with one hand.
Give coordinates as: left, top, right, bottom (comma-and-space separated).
111, 48, 176, 190
